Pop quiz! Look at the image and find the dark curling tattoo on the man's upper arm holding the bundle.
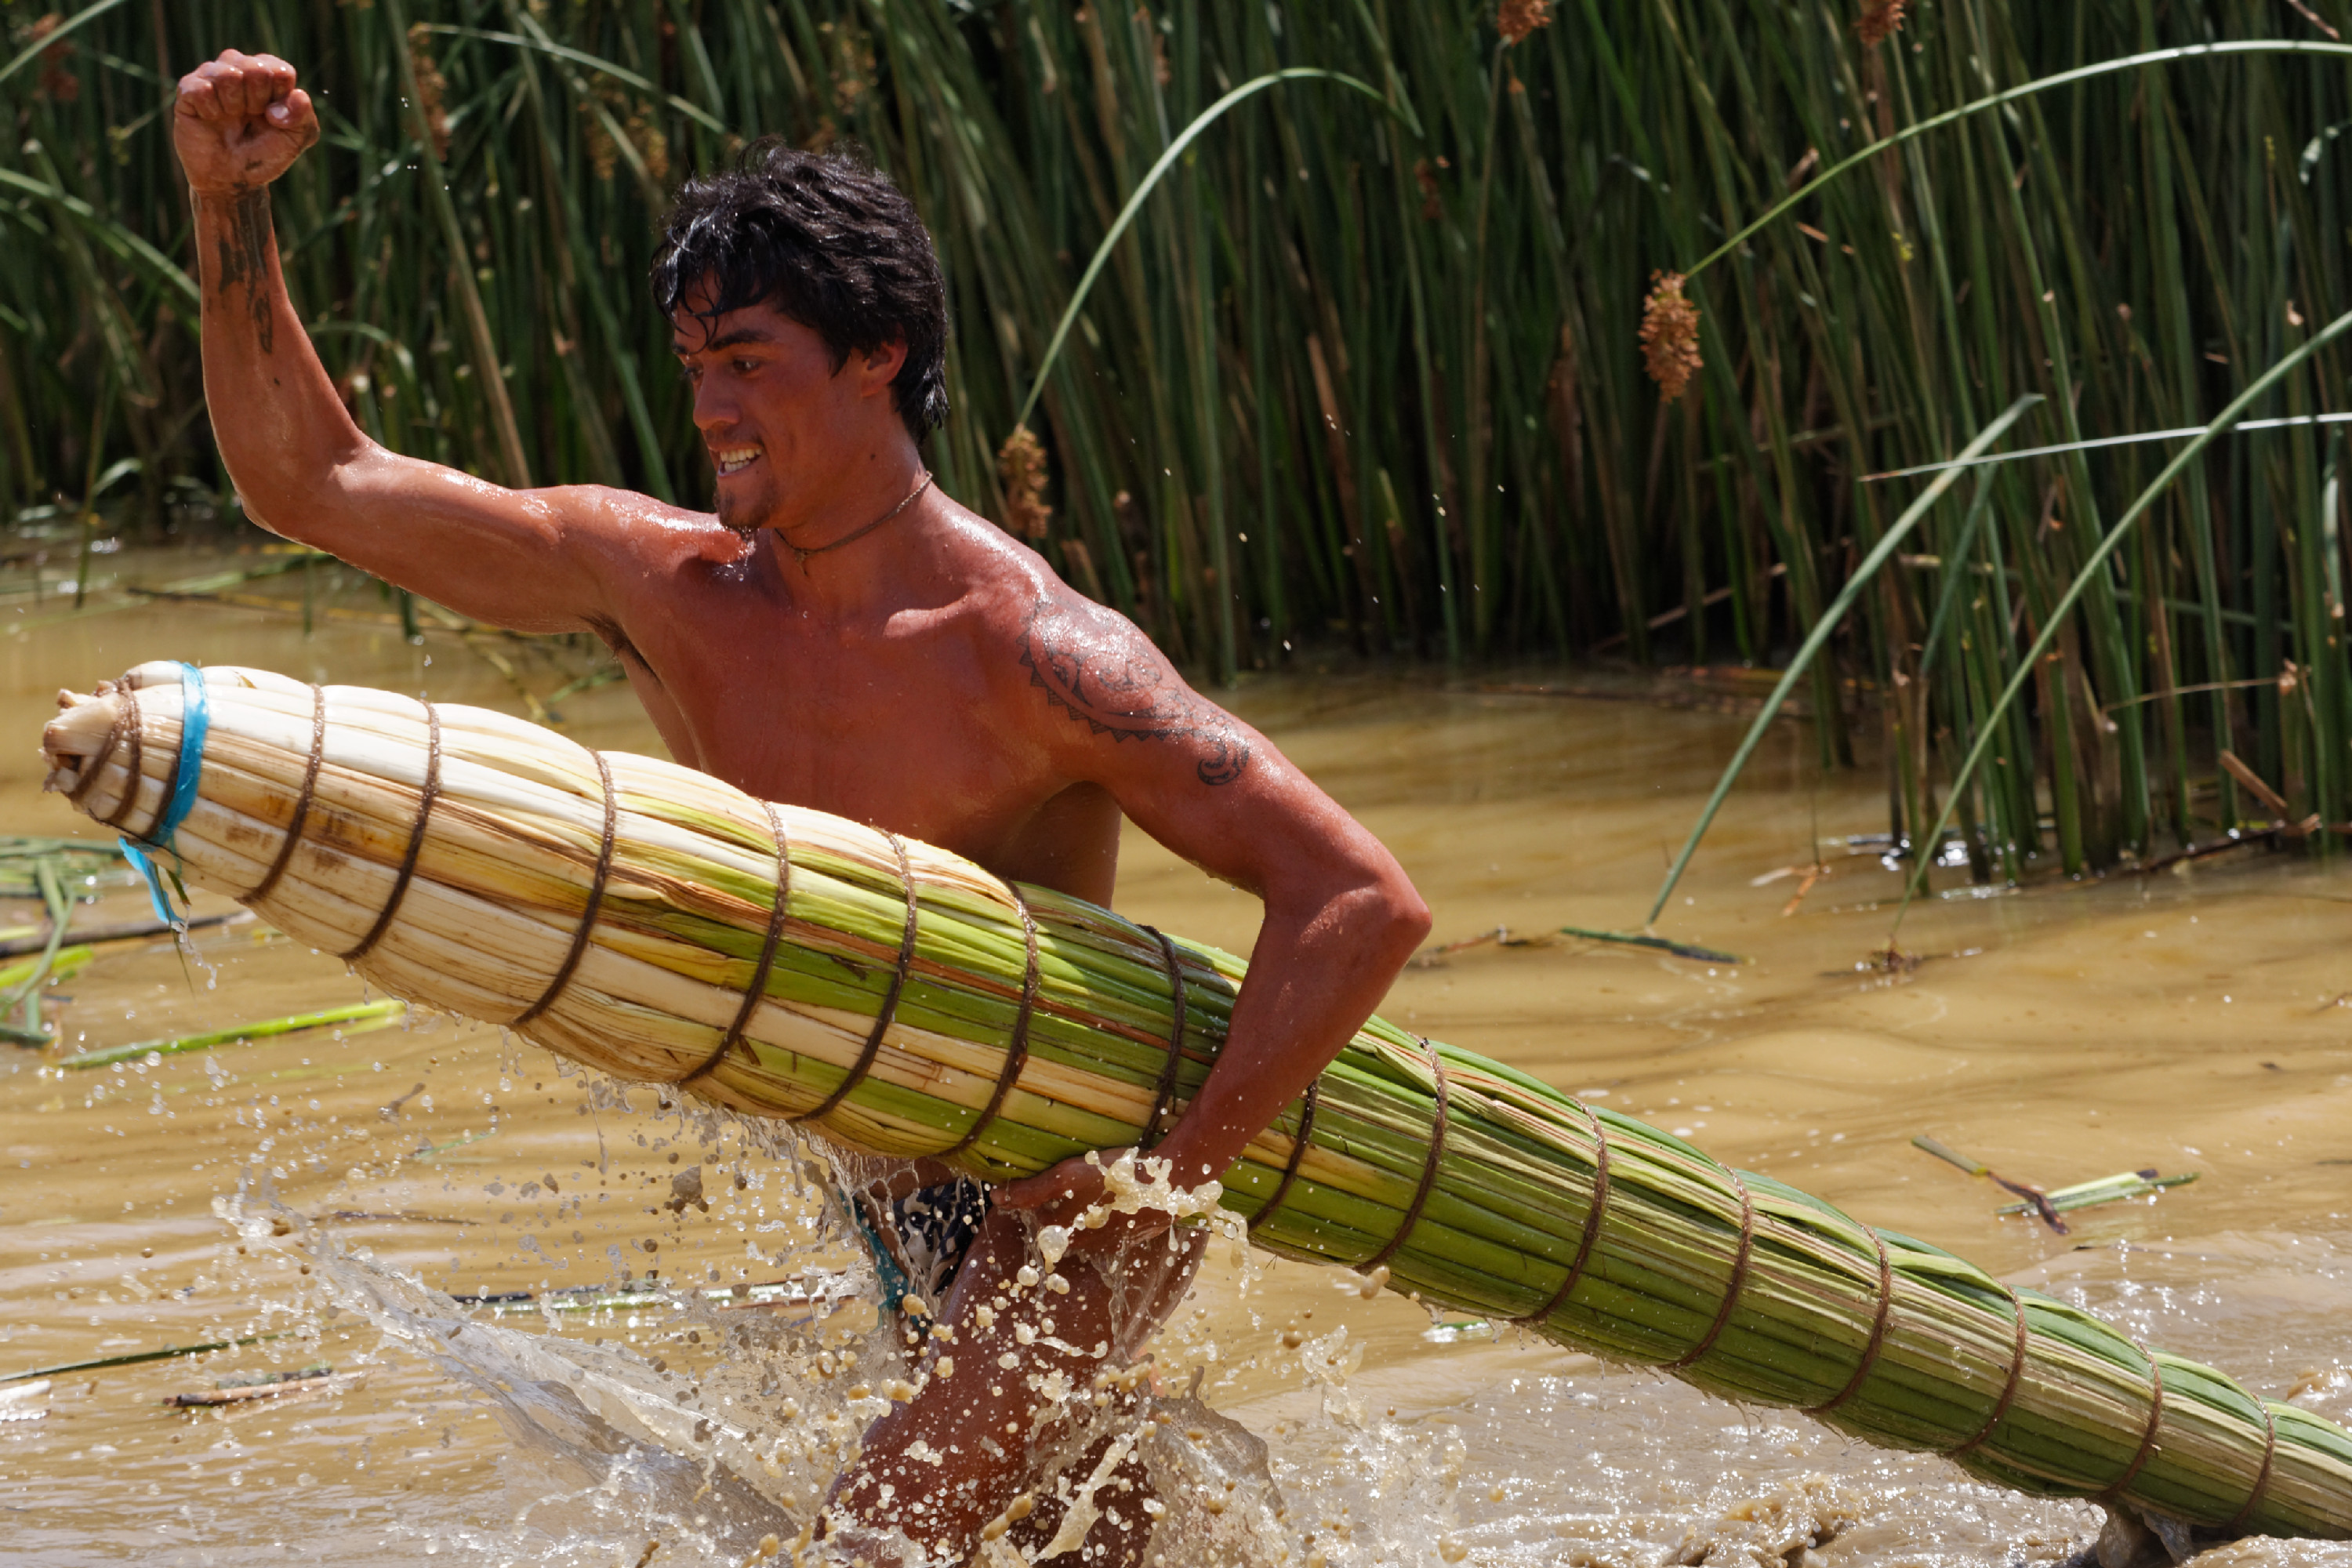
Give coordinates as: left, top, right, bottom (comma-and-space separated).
1021, 600, 1249, 785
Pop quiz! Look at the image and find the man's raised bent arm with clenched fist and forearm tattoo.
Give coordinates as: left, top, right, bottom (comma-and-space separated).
172, 49, 656, 633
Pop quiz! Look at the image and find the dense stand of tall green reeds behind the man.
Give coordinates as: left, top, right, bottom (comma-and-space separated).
0, 0, 2352, 877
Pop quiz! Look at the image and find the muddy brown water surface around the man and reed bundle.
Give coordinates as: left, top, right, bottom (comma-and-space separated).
0, 557, 2352, 1568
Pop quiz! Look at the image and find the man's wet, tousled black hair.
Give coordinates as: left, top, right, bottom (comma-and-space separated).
654, 136, 948, 442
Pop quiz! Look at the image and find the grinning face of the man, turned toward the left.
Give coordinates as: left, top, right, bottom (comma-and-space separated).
670, 289, 875, 534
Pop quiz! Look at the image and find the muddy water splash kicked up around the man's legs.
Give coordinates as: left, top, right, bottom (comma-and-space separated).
202, 1161, 1461, 1568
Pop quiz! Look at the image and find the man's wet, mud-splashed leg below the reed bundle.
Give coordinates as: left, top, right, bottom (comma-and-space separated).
828, 1213, 1204, 1561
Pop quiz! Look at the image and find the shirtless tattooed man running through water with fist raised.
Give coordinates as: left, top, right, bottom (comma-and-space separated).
174, 49, 1428, 1561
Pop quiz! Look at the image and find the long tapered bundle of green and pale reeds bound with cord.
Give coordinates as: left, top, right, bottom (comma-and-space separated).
42, 663, 2352, 1537
